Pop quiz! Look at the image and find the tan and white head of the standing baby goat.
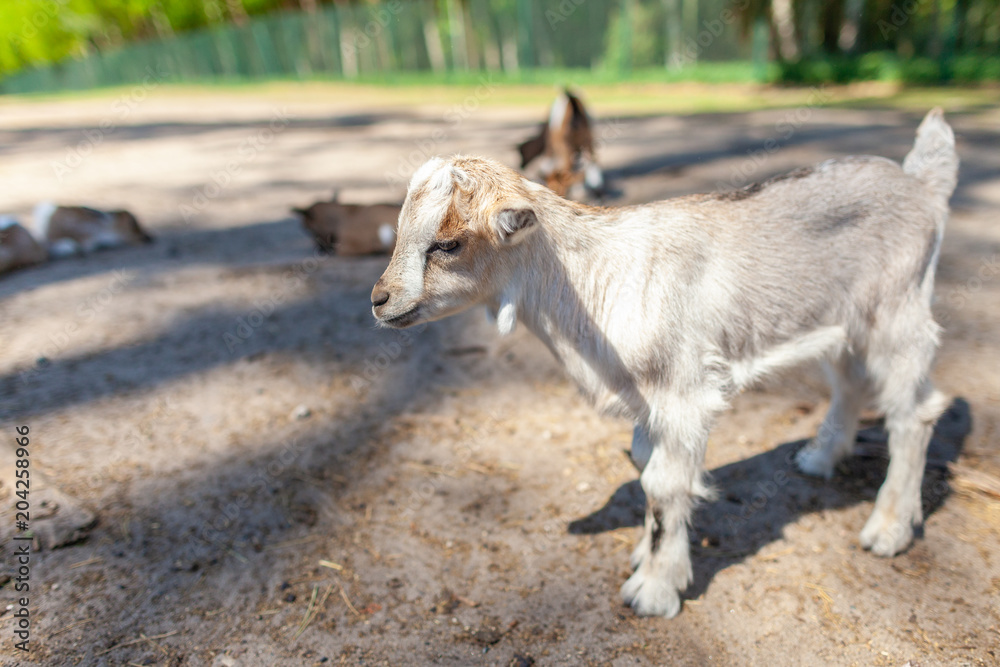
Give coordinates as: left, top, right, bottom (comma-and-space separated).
372, 157, 542, 328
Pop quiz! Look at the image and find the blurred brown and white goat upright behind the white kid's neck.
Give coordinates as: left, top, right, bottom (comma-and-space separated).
517, 90, 604, 199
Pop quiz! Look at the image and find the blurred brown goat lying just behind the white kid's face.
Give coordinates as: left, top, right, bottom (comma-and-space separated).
292, 194, 402, 257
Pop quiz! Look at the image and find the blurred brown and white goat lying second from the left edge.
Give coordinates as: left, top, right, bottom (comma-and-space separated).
34, 202, 153, 257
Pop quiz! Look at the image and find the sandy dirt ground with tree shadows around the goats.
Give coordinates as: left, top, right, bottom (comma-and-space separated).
0, 85, 1000, 667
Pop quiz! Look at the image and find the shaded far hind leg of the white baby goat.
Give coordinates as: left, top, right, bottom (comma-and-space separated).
795, 352, 869, 479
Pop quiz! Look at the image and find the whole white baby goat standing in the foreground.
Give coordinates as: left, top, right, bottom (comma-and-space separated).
372, 109, 958, 617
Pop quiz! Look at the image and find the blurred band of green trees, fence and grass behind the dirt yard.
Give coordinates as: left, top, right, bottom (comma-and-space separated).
0, 0, 1000, 92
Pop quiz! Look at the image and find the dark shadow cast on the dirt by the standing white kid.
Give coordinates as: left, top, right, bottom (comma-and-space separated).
568, 398, 972, 598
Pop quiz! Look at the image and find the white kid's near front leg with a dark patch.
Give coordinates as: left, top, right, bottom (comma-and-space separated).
621, 418, 708, 618
